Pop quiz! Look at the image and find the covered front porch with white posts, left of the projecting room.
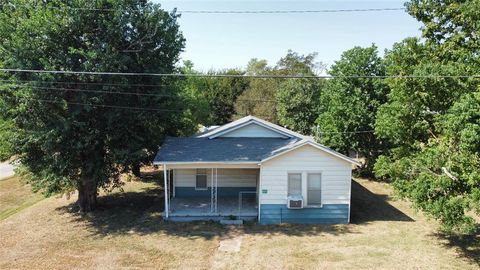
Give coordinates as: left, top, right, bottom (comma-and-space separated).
163, 164, 260, 221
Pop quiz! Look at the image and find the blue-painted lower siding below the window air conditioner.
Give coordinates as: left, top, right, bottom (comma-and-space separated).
260, 204, 349, 224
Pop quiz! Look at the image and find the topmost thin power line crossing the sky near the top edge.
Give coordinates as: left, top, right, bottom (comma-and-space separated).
5, 4, 406, 14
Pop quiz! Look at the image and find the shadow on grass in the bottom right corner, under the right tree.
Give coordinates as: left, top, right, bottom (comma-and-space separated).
433, 229, 480, 266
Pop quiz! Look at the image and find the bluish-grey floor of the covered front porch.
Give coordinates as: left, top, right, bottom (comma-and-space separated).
169, 197, 258, 217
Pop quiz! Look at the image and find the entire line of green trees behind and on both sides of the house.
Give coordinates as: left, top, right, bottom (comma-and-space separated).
0, 0, 480, 232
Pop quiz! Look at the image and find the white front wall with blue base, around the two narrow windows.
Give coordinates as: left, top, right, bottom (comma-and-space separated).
259, 145, 352, 223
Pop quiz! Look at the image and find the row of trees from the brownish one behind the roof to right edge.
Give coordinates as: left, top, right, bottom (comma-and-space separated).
181, 0, 480, 232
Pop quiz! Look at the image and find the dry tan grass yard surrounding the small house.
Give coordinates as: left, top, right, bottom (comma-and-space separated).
0, 177, 480, 269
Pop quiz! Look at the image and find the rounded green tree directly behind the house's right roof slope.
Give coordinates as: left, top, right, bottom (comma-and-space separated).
316, 45, 388, 176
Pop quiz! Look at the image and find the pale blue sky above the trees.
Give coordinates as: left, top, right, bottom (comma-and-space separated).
154, 0, 420, 71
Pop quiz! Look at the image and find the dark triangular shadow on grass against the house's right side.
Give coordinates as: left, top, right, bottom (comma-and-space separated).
350, 180, 414, 224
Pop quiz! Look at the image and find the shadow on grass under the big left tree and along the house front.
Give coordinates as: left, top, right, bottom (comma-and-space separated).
57, 184, 351, 239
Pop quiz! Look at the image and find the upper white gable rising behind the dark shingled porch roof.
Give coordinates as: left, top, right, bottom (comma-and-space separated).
197, 116, 304, 139
